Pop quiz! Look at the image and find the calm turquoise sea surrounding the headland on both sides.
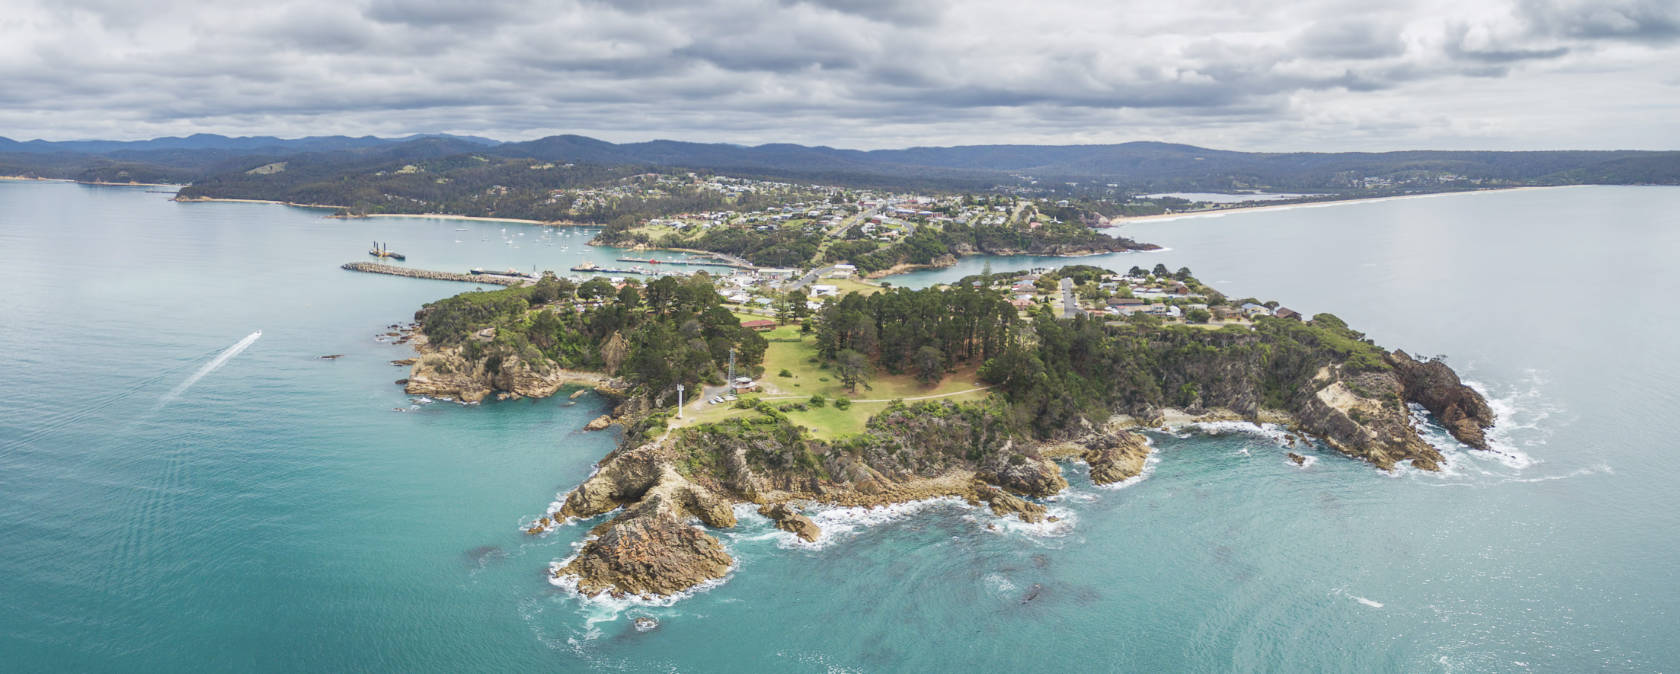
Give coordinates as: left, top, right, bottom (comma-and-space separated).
0, 182, 1680, 671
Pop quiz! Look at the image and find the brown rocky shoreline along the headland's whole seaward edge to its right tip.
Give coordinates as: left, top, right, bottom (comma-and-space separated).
526, 351, 1494, 598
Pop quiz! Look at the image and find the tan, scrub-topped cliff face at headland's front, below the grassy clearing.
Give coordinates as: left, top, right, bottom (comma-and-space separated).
529, 403, 1147, 595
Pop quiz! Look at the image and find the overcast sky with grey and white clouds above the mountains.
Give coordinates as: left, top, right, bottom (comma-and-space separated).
0, 0, 1680, 151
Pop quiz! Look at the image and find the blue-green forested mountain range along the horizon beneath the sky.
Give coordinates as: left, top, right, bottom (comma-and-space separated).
0, 134, 1680, 192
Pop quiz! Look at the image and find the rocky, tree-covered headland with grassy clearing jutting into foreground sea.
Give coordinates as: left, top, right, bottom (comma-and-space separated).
407, 267, 1494, 597
